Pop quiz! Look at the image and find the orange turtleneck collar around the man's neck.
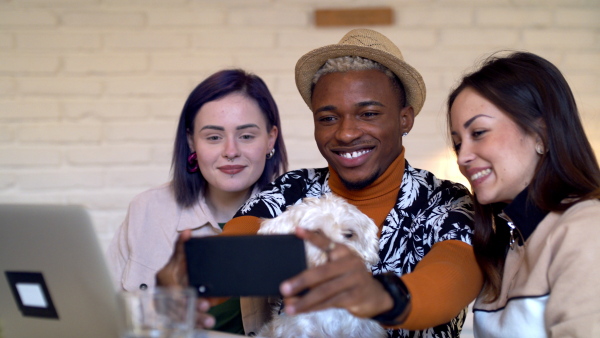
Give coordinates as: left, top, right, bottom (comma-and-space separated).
329, 147, 405, 201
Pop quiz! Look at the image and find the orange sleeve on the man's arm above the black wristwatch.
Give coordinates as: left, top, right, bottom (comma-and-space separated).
396, 240, 483, 330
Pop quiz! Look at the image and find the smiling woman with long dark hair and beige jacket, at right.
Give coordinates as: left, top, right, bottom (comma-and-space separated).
448, 52, 600, 337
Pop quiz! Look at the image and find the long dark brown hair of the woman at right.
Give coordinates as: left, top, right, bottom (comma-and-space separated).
448, 52, 600, 302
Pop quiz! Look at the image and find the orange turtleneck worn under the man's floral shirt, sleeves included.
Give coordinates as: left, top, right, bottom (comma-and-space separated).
223, 149, 483, 330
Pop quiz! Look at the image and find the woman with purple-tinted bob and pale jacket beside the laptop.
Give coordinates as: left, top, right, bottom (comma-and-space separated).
108, 69, 287, 333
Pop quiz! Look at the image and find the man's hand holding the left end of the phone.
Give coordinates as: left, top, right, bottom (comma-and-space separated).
156, 230, 215, 329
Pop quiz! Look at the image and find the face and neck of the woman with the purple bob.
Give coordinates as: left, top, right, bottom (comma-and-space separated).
188, 93, 278, 210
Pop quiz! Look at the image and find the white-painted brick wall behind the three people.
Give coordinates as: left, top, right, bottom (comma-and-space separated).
0, 0, 600, 336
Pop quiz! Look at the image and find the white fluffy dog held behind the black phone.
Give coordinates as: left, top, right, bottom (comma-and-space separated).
258, 194, 387, 338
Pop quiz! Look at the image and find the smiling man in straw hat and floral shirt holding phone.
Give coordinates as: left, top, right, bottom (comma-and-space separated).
159, 29, 482, 337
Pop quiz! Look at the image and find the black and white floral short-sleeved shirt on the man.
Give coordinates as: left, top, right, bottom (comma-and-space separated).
236, 162, 473, 338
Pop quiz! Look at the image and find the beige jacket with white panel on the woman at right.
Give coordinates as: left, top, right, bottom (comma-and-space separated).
473, 200, 600, 338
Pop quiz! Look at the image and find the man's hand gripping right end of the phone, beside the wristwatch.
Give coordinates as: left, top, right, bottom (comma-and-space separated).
280, 228, 394, 318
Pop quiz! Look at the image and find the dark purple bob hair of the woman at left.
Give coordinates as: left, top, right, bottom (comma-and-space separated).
171, 69, 288, 207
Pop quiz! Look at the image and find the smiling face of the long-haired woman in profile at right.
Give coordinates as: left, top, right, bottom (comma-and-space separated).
450, 88, 541, 204
